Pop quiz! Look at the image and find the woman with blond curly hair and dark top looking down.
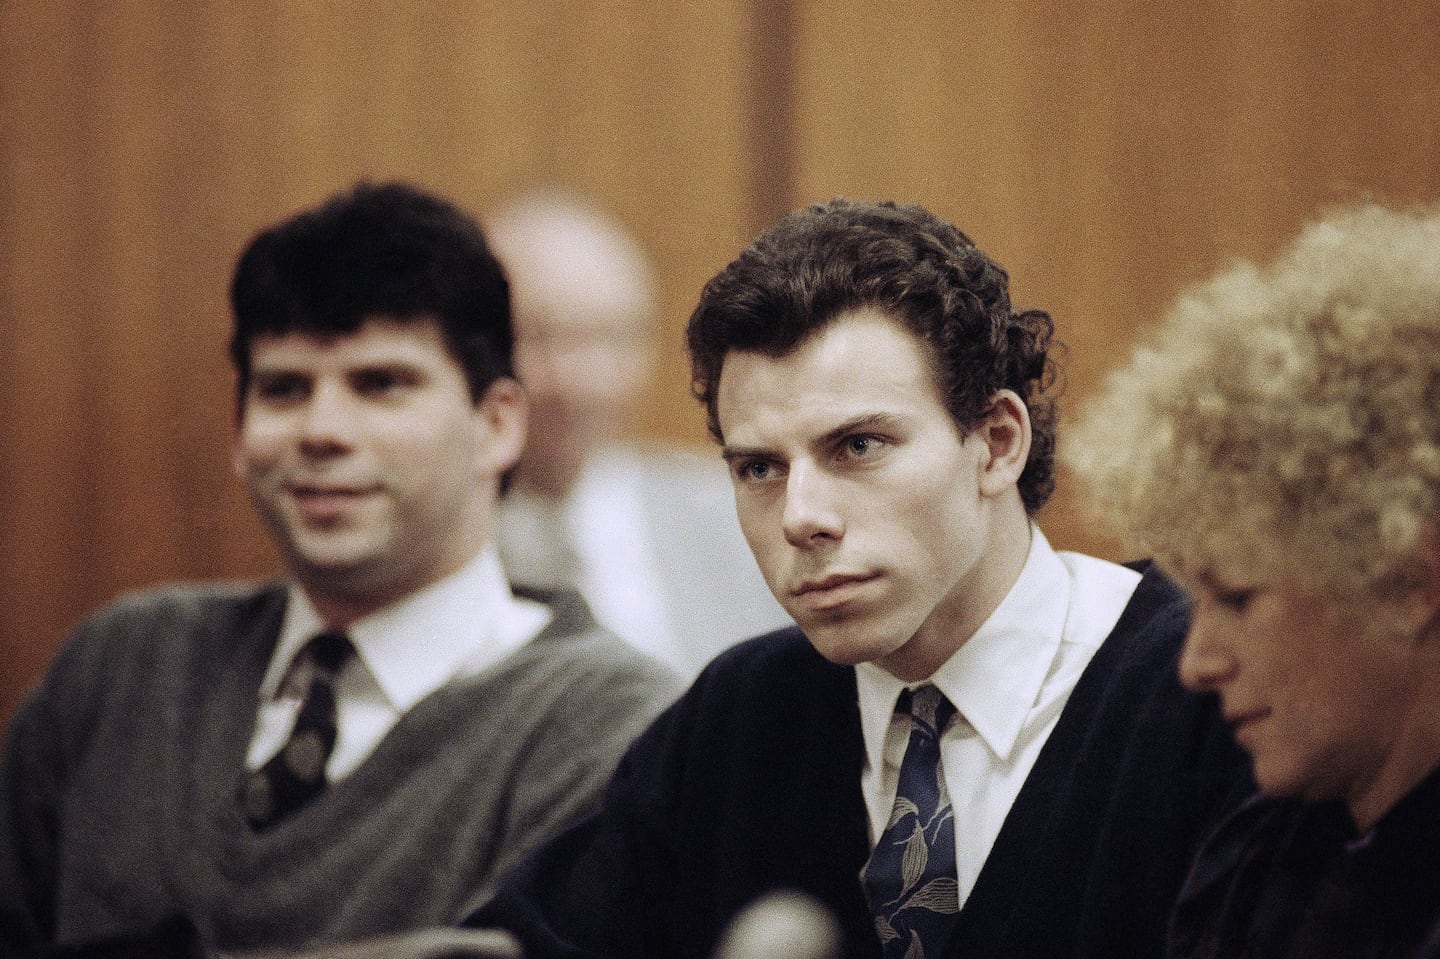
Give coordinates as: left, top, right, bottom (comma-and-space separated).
1067, 206, 1440, 959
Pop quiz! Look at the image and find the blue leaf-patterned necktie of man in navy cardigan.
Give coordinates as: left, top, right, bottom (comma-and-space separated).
860, 684, 960, 959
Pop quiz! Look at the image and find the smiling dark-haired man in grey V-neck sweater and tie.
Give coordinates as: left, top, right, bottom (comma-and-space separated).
0, 184, 677, 956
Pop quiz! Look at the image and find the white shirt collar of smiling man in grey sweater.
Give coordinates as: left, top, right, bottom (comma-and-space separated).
261, 546, 550, 713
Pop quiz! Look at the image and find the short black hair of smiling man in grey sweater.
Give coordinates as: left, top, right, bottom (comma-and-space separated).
230, 181, 514, 408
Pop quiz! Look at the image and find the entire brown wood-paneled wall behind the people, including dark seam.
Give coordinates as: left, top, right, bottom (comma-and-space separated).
0, 0, 1440, 716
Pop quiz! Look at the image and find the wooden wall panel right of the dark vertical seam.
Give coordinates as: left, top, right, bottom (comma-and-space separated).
795, 0, 1440, 556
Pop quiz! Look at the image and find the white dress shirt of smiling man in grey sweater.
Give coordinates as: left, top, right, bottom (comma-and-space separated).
245, 547, 552, 782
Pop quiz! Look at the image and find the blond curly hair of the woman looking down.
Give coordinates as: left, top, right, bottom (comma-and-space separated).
1063, 206, 1440, 596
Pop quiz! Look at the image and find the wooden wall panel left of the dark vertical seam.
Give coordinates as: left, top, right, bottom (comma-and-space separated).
0, 0, 750, 716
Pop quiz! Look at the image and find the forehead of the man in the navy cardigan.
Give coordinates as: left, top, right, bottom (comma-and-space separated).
716, 308, 949, 445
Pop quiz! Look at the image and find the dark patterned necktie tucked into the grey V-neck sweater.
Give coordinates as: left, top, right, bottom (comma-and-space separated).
240, 632, 354, 829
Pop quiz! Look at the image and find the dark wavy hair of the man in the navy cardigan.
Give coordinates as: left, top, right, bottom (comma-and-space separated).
685, 199, 1058, 514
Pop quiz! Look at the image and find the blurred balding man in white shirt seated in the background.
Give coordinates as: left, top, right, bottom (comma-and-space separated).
485, 192, 789, 674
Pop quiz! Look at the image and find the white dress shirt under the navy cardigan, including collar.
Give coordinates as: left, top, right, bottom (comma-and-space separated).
855, 527, 1140, 906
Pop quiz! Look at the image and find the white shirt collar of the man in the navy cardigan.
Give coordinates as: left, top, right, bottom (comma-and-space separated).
855, 526, 1071, 765
